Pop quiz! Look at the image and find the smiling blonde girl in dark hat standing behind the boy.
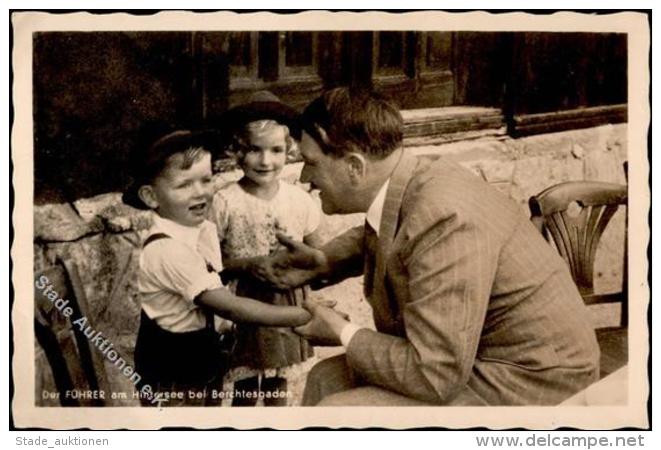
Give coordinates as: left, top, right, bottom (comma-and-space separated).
211, 92, 321, 406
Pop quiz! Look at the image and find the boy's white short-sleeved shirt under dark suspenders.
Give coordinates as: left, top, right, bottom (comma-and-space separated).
138, 213, 232, 333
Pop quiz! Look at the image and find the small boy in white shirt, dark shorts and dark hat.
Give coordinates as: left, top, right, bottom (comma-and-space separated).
124, 131, 310, 405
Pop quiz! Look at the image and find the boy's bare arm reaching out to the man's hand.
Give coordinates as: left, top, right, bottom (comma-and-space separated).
195, 288, 311, 327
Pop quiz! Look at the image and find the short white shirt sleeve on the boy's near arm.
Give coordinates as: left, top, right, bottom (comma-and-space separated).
141, 243, 222, 302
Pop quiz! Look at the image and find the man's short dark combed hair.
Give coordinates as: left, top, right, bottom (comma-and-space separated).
301, 87, 404, 159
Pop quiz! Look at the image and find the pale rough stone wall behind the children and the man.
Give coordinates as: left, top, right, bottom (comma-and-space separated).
34, 124, 627, 403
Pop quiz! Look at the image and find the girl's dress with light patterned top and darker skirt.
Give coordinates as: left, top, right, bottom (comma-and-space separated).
206, 181, 321, 404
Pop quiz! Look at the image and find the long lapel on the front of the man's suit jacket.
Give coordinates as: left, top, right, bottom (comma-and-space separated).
366, 153, 418, 333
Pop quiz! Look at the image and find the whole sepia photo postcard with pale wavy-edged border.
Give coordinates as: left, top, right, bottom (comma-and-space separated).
10, 11, 651, 430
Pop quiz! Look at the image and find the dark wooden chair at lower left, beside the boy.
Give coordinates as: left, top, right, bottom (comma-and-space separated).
34, 260, 110, 406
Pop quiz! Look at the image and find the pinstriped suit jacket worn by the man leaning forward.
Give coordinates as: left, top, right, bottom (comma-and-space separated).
325, 154, 599, 405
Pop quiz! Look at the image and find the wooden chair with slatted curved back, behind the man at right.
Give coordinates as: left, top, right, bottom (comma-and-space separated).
529, 181, 628, 377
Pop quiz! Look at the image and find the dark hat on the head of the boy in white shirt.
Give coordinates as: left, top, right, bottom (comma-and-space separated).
122, 130, 210, 209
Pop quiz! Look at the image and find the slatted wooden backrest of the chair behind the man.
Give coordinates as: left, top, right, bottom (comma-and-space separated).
529, 181, 627, 298
